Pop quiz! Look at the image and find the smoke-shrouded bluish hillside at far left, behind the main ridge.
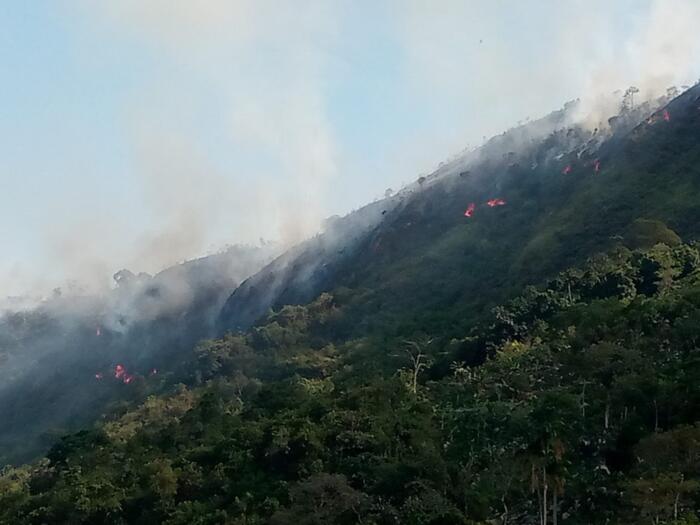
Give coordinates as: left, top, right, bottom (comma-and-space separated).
0, 246, 276, 464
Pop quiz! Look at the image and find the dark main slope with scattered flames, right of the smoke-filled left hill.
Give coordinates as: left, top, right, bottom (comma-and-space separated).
221, 86, 700, 340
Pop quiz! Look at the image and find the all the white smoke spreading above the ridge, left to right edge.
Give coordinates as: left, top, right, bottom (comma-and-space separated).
0, 0, 700, 295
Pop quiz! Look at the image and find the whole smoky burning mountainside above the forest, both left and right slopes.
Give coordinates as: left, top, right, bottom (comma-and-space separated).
0, 87, 700, 472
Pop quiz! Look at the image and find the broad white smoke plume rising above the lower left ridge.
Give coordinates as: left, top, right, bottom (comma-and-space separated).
0, 0, 338, 296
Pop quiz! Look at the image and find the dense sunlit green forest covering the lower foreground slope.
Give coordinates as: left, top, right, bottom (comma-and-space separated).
0, 241, 700, 525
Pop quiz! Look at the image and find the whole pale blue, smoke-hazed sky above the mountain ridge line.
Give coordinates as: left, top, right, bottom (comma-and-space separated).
0, 0, 700, 296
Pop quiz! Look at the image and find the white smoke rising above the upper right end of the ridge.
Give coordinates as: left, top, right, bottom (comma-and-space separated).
397, 0, 700, 157
